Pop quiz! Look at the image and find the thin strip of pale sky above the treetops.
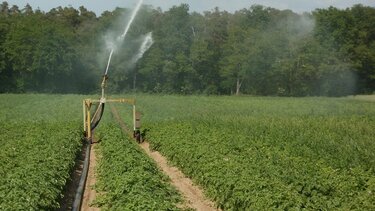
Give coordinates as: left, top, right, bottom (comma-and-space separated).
5, 0, 375, 16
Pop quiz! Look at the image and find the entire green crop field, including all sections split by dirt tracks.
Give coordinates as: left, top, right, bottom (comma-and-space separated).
0, 94, 375, 210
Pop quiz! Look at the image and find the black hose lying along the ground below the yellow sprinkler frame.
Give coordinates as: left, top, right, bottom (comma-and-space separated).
72, 140, 91, 211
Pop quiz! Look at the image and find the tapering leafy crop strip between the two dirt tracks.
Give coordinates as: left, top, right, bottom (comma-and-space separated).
94, 119, 181, 210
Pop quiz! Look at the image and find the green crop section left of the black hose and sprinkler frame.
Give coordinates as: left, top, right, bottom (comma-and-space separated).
0, 95, 82, 210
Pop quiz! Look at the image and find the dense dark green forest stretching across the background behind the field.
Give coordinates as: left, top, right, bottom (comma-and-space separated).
0, 2, 375, 96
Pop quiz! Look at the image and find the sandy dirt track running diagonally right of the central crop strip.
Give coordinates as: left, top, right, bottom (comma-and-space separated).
111, 106, 218, 211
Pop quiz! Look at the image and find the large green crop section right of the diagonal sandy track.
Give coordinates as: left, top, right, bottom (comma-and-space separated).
117, 95, 375, 210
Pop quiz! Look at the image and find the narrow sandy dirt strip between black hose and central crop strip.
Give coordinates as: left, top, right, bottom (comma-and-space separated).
81, 144, 100, 211
